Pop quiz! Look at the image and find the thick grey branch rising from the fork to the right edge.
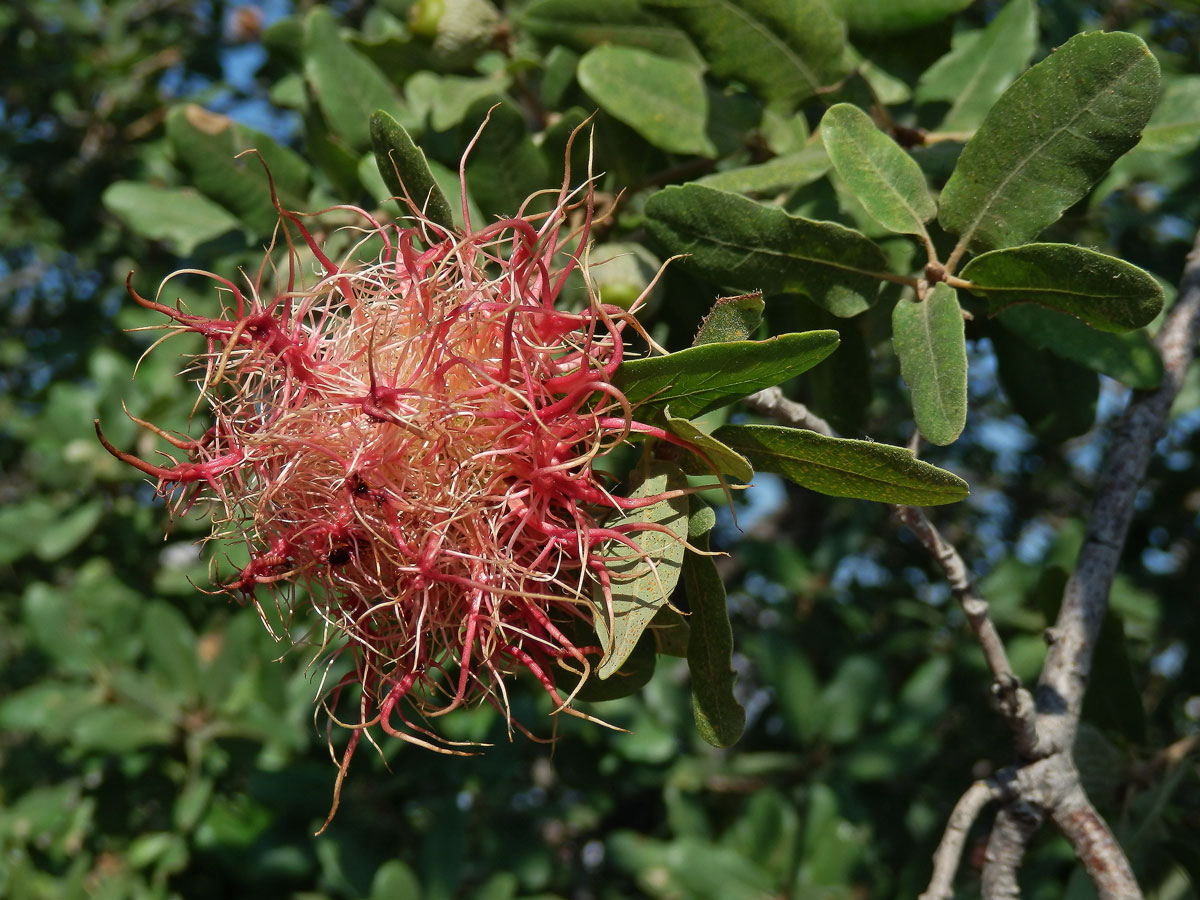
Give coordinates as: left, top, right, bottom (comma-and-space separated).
1037, 235, 1200, 752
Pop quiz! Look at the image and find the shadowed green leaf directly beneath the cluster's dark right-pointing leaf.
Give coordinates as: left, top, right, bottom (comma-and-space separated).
997, 305, 1163, 390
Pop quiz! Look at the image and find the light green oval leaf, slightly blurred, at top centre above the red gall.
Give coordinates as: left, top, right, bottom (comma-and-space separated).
577, 46, 716, 156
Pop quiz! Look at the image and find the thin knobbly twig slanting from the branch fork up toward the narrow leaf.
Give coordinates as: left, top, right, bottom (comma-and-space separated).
896, 506, 1038, 757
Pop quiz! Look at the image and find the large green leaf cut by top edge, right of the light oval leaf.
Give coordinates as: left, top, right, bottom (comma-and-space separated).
648, 0, 846, 107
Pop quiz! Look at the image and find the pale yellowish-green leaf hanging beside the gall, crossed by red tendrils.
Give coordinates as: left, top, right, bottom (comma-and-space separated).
594, 462, 688, 680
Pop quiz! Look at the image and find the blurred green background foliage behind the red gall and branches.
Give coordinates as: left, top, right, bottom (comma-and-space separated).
0, 0, 1200, 900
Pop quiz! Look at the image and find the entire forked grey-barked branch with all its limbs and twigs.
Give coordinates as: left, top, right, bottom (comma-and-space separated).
749, 243, 1200, 900
